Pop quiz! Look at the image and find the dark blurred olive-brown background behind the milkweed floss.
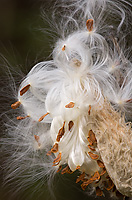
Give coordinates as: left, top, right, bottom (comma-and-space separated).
0, 0, 131, 200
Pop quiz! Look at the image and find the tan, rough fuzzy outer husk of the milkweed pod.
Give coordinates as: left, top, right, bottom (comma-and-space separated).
96, 103, 132, 196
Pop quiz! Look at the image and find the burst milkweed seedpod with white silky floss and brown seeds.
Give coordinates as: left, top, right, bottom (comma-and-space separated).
3, 0, 132, 198
